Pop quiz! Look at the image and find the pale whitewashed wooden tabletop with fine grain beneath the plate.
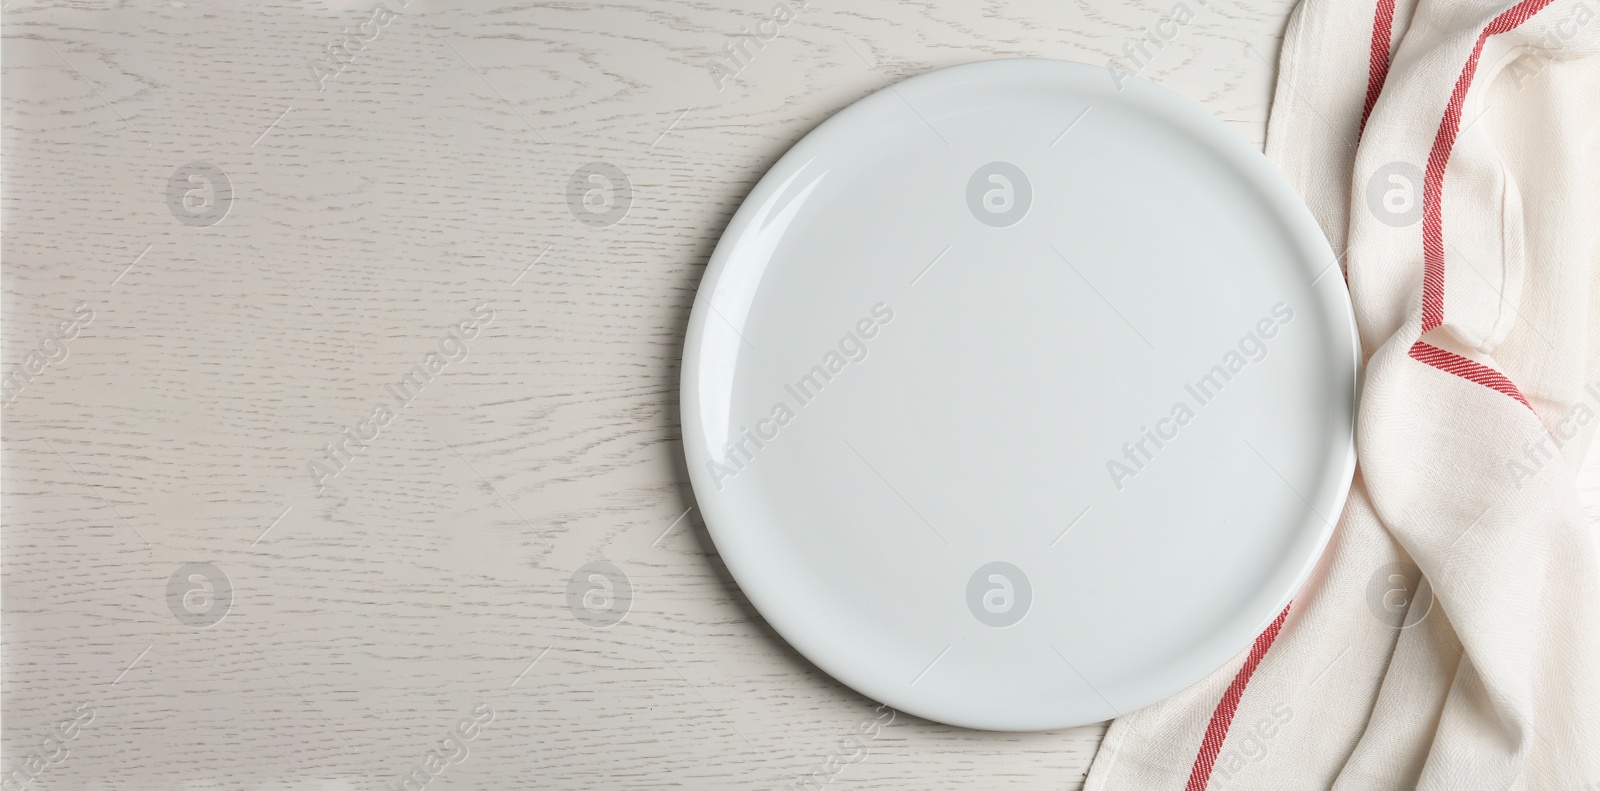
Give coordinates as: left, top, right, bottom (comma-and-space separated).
0, 0, 1587, 789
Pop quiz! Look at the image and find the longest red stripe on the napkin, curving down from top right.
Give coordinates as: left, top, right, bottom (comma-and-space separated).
1422, 0, 1550, 335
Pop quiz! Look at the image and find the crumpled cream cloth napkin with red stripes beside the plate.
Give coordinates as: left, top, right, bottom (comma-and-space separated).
1086, 0, 1600, 791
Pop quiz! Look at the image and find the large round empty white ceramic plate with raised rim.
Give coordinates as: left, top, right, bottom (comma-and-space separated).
682, 61, 1357, 730
